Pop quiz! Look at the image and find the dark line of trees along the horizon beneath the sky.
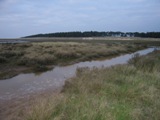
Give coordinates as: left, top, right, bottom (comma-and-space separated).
24, 31, 160, 38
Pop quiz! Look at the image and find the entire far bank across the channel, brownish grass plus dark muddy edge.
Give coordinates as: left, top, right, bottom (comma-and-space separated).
0, 42, 145, 79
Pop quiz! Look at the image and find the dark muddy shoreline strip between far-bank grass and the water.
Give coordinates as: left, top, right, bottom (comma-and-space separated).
0, 46, 147, 80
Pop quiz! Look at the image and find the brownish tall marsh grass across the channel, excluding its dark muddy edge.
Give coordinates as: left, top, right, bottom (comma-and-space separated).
0, 42, 143, 66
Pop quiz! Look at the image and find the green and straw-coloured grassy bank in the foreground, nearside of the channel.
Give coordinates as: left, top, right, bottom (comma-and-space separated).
3, 51, 160, 120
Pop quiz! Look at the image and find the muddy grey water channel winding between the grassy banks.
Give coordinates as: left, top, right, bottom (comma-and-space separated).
0, 48, 155, 100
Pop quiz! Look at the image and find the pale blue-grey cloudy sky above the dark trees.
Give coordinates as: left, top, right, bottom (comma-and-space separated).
0, 0, 160, 38
